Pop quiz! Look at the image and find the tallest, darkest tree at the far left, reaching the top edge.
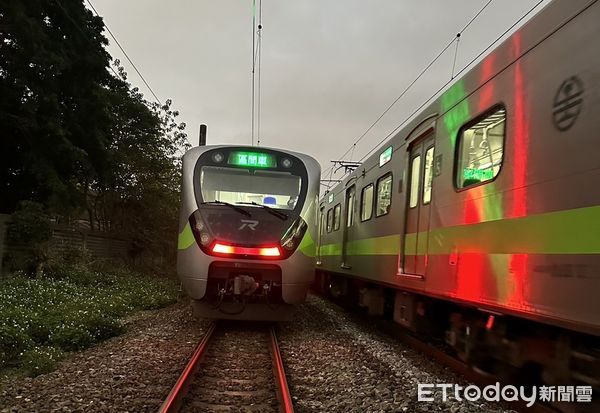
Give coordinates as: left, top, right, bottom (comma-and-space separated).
0, 0, 111, 212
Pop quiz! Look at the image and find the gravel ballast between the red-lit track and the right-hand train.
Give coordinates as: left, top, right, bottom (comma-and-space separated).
279, 296, 507, 413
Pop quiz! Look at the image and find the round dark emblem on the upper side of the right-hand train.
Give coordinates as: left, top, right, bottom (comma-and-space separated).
552, 76, 583, 132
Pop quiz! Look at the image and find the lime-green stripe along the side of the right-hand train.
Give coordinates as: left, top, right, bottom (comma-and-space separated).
320, 206, 600, 256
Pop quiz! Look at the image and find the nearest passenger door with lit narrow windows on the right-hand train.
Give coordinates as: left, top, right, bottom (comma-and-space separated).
403, 133, 434, 276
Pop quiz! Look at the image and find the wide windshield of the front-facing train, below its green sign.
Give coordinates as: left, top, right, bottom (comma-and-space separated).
200, 166, 302, 210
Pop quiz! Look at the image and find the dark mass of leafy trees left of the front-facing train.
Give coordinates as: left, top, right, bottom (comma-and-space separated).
0, 0, 189, 262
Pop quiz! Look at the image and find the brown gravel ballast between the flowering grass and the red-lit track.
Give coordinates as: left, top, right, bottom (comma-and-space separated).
0, 300, 208, 413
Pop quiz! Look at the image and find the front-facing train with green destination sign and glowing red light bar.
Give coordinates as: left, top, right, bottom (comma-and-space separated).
177, 146, 321, 320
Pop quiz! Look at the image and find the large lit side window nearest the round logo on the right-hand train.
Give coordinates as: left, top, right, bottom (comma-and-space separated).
455, 107, 506, 189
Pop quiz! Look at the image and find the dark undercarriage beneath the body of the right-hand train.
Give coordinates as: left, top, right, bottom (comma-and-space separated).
314, 272, 600, 402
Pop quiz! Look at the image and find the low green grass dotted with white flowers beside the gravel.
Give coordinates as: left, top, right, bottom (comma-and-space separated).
0, 262, 177, 376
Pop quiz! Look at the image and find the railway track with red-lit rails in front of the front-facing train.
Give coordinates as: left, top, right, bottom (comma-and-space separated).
159, 321, 294, 413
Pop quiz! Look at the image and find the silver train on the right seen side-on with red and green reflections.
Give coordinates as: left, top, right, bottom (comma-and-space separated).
316, 0, 600, 391
